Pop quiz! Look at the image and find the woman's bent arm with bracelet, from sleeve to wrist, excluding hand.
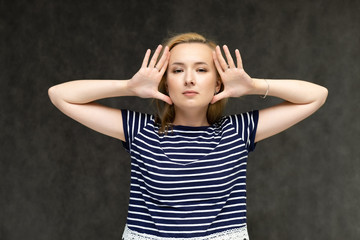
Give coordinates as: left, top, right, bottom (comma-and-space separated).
249, 79, 328, 142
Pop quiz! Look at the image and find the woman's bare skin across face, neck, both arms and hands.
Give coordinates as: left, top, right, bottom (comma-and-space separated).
49, 43, 328, 142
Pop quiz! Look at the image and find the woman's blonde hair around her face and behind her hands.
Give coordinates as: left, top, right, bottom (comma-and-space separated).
155, 32, 227, 134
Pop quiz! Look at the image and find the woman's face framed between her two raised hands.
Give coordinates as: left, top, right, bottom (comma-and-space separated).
167, 43, 220, 109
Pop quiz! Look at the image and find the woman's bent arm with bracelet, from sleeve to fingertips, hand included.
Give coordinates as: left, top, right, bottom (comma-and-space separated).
212, 46, 328, 142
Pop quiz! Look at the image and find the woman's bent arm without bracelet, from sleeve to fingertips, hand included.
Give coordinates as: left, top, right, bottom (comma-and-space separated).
48, 46, 171, 141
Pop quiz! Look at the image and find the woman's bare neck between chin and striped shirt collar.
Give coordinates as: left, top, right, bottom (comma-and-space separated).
173, 107, 209, 127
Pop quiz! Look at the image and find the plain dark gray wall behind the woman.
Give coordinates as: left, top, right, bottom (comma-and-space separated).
0, 0, 360, 240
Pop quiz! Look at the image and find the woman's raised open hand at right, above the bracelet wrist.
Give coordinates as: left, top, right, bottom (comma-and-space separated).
211, 45, 254, 103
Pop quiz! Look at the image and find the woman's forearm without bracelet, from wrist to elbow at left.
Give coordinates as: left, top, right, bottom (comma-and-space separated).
49, 80, 132, 104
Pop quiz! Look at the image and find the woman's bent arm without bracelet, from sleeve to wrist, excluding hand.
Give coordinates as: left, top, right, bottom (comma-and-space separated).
49, 80, 131, 141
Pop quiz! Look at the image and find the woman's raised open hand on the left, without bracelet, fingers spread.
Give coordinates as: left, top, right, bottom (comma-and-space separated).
128, 45, 172, 105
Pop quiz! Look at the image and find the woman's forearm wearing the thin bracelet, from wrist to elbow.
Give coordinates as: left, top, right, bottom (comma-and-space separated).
250, 78, 328, 105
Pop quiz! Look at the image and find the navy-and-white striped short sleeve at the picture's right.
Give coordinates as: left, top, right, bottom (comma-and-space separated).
230, 110, 259, 152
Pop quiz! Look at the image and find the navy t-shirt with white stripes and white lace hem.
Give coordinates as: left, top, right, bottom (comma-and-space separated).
122, 110, 258, 240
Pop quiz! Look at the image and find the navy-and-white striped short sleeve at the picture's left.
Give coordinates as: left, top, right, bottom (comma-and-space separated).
121, 109, 150, 152
